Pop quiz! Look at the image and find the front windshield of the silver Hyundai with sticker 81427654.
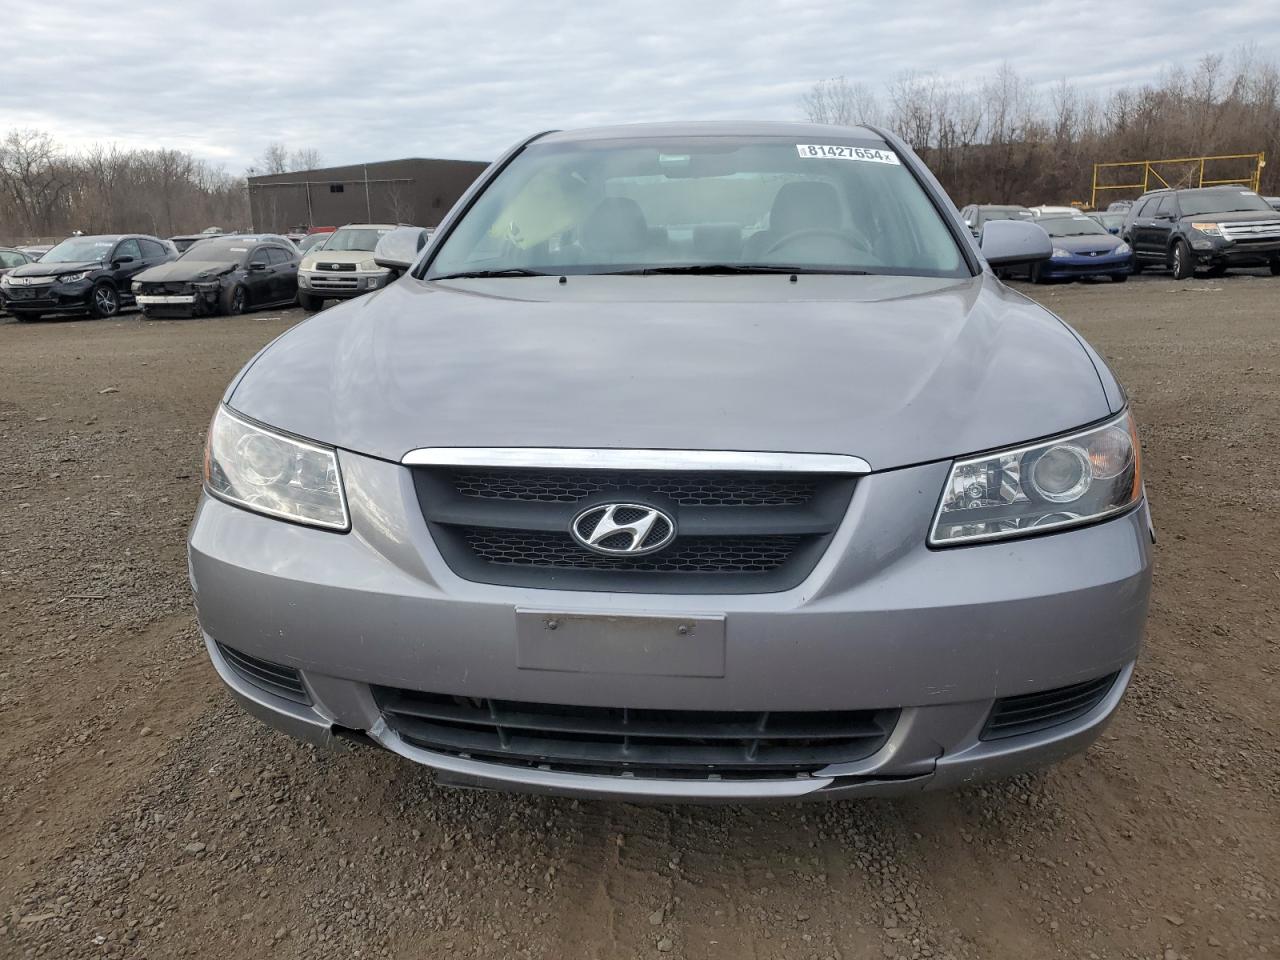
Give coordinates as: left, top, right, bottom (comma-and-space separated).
424, 137, 969, 279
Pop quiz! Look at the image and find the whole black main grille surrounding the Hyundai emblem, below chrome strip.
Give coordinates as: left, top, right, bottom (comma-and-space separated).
413, 466, 855, 593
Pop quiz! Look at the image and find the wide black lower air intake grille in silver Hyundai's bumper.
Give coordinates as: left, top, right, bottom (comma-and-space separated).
374, 687, 899, 780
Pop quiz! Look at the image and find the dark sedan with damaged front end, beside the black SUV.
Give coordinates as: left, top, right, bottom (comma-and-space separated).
133, 234, 298, 317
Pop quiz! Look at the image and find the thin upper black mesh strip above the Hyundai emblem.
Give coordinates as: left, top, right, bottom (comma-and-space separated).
451, 470, 817, 507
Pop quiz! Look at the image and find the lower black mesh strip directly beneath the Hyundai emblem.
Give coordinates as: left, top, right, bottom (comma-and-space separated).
466, 527, 801, 573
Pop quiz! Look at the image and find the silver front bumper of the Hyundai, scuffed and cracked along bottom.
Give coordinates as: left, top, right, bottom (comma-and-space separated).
189, 453, 1151, 800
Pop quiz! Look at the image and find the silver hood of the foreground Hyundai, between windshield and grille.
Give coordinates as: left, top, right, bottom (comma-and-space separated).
227, 274, 1119, 470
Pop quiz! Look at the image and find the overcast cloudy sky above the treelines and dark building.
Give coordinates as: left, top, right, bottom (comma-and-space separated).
0, 0, 1264, 173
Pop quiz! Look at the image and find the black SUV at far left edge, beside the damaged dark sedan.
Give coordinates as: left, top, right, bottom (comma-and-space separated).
0, 234, 178, 320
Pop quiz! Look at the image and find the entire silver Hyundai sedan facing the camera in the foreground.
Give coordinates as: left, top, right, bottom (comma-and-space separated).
189, 123, 1153, 800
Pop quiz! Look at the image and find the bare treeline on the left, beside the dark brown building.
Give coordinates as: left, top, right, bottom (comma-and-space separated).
0, 136, 320, 243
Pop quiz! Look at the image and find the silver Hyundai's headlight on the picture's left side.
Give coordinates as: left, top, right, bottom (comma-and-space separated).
205, 406, 351, 530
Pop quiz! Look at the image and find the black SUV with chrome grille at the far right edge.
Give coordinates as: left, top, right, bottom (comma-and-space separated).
1123, 186, 1280, 280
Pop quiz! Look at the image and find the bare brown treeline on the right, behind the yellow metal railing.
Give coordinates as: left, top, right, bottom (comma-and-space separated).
803, 49, 1280, 207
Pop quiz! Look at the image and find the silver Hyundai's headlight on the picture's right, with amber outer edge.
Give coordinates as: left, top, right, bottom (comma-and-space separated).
929, 413, 1142, 547
